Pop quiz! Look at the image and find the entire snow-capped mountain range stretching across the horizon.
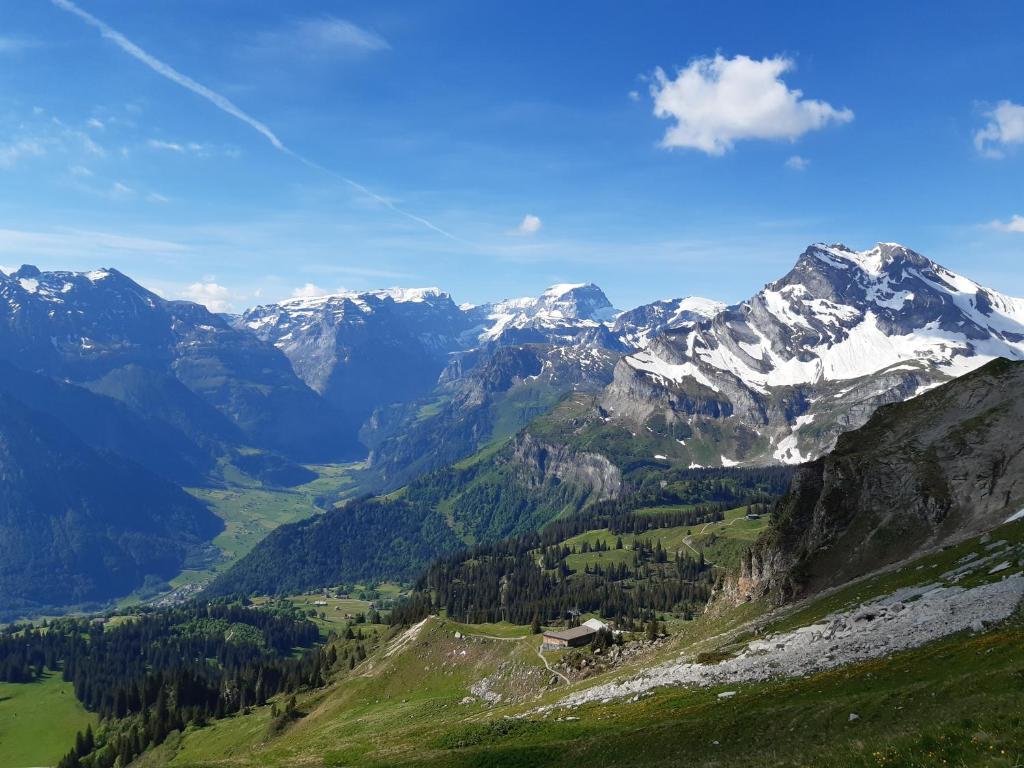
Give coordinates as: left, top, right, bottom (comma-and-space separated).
0, 244, 1024, 618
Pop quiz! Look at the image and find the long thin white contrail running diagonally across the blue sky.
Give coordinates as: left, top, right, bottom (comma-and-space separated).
50, 0, 467, 243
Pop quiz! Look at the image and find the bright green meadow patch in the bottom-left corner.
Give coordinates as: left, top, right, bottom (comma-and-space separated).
0, 672, 97, 768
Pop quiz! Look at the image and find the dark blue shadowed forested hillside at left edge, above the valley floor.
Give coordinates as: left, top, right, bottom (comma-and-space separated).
0, 393, 222, 618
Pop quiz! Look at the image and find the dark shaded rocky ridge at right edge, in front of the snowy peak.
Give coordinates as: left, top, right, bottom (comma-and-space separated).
724, 359, 1024, 602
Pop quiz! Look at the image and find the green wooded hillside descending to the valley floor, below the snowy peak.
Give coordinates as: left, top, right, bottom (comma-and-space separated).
207, 432, 790, 595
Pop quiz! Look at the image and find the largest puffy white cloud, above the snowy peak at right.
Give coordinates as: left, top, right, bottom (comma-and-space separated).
650, 55, 853, 155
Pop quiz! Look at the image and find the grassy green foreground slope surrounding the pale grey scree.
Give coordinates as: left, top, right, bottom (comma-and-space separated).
128, 523, 1024, 768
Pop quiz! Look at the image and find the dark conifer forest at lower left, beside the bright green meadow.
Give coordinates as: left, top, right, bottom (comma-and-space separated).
0, 601, 336, 768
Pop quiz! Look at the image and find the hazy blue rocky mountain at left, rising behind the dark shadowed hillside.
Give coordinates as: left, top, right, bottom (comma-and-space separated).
0, 266, 351, 460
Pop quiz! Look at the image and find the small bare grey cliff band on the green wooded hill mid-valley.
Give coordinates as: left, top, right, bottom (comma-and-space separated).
512, 432, 623, 501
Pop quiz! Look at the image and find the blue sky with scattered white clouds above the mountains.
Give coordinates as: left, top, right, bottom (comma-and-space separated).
0, 0, 1024, 311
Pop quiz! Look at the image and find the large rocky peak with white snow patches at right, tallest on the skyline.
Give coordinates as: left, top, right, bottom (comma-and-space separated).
602, 244, 1024, 464
